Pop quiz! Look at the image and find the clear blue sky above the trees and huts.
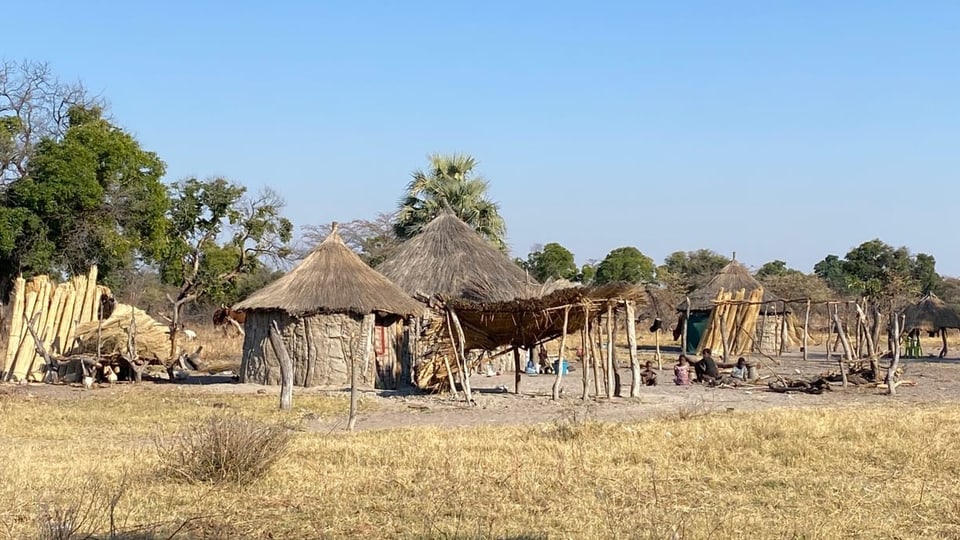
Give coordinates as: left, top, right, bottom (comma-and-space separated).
0, 0, 960, 275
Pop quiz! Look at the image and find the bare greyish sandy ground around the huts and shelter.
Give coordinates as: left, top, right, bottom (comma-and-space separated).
7, 346, 960, 431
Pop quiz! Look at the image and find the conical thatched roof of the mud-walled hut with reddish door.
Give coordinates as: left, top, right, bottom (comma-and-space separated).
233, 224, 423, 316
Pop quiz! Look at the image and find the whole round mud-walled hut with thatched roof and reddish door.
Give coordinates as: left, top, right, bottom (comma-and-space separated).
233, 224, 424, 388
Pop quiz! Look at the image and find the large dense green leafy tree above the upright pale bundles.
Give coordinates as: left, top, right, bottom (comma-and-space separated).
0, 106, 169, 288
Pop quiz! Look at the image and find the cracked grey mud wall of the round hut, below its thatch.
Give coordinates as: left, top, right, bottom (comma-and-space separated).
240, 311, 374, 388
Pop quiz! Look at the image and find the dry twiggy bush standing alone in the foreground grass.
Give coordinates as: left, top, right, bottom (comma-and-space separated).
155, 415, 291, 485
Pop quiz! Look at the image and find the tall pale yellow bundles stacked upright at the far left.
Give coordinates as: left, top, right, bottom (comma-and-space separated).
0, 266, 113, 381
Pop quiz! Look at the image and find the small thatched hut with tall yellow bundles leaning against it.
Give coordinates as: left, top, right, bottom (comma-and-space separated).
675, 256, 794, 354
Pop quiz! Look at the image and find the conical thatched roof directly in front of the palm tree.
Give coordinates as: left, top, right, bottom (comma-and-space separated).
377, 210, 540, 302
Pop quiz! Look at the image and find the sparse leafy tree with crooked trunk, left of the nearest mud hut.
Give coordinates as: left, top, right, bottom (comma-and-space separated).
160, 178, 293, 352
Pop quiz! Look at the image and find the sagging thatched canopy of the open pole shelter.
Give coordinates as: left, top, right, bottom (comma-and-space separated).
441, 283, 647, 350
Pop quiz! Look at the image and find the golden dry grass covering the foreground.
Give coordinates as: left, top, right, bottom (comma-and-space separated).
0, 389, 960, 538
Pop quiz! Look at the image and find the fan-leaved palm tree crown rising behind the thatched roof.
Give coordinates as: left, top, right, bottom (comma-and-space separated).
394, 154, 507, 252
